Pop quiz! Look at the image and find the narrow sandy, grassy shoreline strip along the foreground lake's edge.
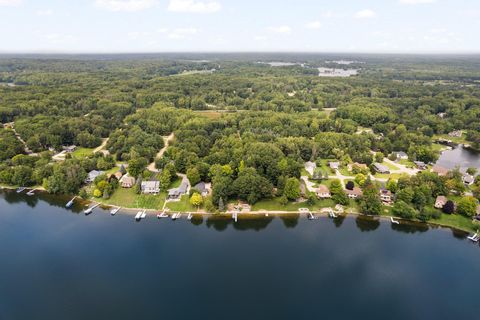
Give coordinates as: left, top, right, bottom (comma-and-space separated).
0, 185, 480, 233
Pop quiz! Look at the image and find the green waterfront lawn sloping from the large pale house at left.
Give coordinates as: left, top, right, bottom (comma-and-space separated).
102, 188, 166, 210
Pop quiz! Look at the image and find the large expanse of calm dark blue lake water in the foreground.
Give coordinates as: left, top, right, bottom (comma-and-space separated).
0, 191, 480, 320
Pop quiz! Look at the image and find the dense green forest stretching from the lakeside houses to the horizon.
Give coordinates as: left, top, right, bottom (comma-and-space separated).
0, 54, 480, 225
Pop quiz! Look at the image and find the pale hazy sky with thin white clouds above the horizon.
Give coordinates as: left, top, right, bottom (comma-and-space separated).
0, 0, 480, 53
